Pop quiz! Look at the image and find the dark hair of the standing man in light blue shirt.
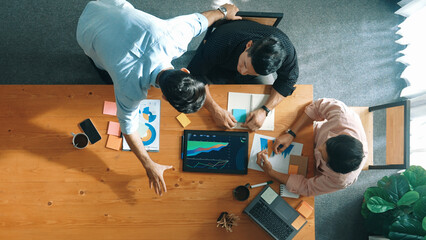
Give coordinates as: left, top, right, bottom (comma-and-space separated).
158, 69, 206, 113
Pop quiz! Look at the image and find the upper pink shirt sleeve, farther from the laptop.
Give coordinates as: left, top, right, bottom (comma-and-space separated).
305, 98, 348, 121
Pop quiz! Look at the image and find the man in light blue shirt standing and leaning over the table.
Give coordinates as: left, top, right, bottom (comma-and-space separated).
77, 0, 240, 195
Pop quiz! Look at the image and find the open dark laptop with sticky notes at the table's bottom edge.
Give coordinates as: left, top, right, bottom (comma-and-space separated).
244, 186, 306, 240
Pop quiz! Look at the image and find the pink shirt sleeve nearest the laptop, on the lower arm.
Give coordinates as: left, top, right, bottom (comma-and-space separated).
286, 174, 346, 196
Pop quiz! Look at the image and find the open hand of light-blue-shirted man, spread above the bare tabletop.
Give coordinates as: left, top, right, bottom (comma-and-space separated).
145, 162, 173, 196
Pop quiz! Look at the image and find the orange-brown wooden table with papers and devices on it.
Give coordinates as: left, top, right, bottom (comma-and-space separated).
0, 85, 315, 240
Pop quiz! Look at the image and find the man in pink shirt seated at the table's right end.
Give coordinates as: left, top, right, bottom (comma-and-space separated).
257, 98, 368, 196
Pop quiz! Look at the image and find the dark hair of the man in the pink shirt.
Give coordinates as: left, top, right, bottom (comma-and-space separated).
326, 134, 364, 174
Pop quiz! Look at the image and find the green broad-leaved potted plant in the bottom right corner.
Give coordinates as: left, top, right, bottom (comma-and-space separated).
361, 166, 426, 240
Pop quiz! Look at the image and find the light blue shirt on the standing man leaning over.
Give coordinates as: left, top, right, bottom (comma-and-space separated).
77, 0, 208, 134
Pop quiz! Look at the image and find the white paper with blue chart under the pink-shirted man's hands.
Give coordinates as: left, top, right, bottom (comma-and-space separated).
248, 134, 303, 173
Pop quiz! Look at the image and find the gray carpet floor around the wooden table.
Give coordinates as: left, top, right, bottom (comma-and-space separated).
0, 0, 406, 240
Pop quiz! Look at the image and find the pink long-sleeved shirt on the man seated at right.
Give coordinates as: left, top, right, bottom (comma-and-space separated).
286, 98, 368, 196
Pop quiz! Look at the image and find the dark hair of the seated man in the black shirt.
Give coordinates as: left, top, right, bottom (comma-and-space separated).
247, 37, 286, 75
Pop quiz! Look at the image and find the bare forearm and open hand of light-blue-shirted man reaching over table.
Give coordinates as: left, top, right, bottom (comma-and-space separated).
123, 132, 173, 196
